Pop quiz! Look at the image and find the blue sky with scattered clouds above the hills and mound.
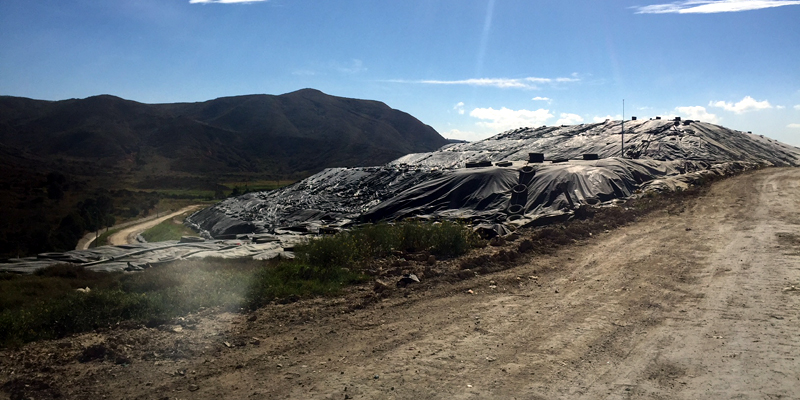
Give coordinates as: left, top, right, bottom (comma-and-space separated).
0, 0, 800, 146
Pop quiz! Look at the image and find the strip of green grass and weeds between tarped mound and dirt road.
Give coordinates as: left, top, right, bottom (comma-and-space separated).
0, 222, 477, 346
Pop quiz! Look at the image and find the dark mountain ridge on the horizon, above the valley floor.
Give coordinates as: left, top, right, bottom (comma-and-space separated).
0, 89, 447, 175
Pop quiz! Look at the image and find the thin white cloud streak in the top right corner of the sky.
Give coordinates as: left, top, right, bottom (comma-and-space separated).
632, 0, 800, 14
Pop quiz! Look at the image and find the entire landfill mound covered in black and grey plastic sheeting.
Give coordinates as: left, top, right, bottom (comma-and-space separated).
0, 119, 800, 272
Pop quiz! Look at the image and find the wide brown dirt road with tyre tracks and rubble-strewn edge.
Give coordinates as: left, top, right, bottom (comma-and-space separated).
0, 169, 800, 399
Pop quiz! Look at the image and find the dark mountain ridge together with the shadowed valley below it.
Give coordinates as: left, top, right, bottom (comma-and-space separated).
0, 89, 447, 259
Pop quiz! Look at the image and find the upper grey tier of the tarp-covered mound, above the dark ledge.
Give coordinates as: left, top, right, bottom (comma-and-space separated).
390, 119, 800, 168
